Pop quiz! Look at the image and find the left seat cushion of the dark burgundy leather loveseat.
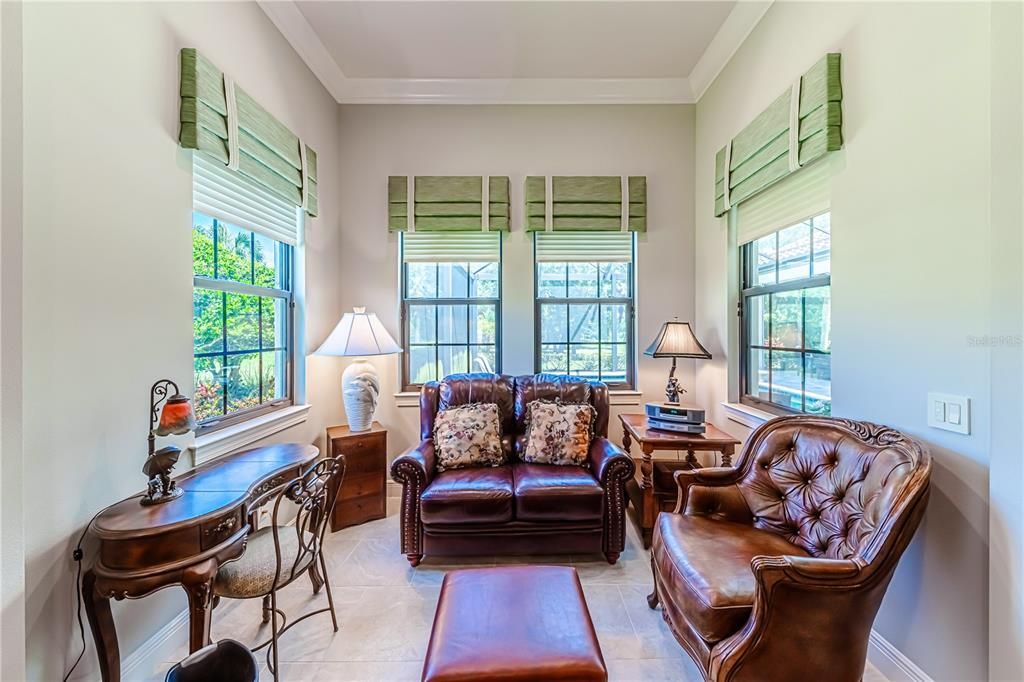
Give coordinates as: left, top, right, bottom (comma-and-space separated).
420, 465, 512, 525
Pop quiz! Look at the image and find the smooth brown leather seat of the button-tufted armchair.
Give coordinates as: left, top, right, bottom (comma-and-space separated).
651, 513, 807, 643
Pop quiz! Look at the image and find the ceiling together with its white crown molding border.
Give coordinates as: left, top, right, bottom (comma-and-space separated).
260, 0, 770, 103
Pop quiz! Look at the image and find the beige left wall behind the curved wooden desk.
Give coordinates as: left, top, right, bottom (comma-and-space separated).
20, 3, 342, 680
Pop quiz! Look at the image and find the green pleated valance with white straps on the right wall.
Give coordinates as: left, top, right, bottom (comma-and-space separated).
715, 52, 843, 216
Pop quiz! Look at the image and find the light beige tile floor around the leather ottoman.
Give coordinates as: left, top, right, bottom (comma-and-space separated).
152, 500, 884, 682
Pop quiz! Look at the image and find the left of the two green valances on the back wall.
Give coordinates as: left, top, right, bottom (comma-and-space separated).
387, 175, 510, 232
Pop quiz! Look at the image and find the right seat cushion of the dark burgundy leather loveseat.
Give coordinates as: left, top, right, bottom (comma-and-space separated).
512, 462, 604, 523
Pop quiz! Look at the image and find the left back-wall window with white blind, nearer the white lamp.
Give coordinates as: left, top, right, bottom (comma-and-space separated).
401, 232, 501, 390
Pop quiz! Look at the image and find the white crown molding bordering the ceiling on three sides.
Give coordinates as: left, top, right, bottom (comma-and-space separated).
258, 0, 772, 104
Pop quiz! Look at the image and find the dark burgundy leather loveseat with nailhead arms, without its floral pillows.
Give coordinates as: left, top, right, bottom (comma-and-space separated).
391, 374, 635, 566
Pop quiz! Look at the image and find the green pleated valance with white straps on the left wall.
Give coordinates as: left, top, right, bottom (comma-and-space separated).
179, 47, 318, 216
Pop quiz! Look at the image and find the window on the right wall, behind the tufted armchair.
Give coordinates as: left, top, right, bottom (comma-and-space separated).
740, 212, 831, 415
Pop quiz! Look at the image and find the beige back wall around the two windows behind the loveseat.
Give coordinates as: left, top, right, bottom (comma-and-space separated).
331, 105, 693, 456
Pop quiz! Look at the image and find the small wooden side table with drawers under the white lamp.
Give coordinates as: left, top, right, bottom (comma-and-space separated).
327, 422, 387, 532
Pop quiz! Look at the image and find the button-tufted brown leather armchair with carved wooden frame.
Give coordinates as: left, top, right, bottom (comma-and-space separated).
648, 416, 932, 682
